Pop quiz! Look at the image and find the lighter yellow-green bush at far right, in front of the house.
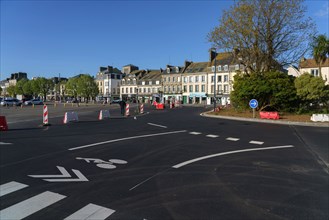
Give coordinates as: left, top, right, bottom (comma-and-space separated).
295, 73, 329, 110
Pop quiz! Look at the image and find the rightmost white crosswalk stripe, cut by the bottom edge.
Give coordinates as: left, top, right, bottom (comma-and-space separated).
64, 203, 115, 220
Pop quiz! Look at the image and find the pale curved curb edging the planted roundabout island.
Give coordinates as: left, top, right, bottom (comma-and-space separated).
200, 111, 329, 127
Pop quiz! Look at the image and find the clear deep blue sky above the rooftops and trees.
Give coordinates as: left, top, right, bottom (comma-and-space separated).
0, 0, 329, 80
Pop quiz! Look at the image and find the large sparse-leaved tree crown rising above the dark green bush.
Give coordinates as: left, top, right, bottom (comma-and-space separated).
207, 0, 315, 73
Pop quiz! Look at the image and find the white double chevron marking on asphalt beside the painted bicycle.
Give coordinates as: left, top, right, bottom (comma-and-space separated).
28, 166, 89, 182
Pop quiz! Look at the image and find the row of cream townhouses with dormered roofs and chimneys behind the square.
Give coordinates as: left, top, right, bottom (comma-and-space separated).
120, 52, 238, 105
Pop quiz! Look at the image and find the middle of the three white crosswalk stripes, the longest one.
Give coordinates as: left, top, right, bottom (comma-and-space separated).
0, 191, 66, 220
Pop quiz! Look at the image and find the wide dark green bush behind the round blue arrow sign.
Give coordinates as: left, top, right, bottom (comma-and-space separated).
231, 71, 296, 111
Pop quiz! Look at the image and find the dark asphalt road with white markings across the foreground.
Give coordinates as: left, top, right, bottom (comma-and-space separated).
0, 105, 329, 220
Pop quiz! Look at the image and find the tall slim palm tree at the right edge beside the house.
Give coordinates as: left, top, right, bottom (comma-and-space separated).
311, 34, 329, 77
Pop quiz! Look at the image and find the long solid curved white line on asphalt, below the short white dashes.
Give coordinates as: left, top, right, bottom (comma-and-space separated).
172, 145, 294, 169
